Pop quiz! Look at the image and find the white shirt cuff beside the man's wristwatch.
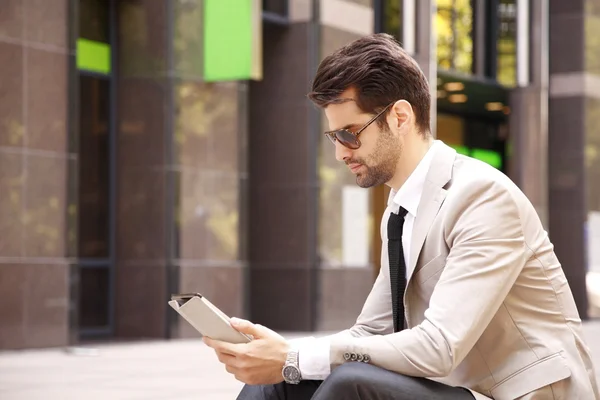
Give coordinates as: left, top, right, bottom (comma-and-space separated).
290, 337, 331, 380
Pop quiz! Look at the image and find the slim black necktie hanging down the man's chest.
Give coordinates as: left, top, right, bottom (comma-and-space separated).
388, 207, 407, 332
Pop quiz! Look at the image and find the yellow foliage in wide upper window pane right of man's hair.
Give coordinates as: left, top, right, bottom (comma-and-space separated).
435, 0, 473, 74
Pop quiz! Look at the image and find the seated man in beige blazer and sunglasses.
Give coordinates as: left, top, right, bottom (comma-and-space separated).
205, 34, 600, 400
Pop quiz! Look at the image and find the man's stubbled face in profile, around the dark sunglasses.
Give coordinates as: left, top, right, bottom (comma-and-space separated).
325, 93, 402, 188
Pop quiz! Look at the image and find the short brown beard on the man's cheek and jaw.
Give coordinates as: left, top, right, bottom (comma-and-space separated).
351, 127, 403, 188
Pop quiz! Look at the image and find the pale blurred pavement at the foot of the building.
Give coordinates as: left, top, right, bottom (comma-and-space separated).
0, 321, 600, 400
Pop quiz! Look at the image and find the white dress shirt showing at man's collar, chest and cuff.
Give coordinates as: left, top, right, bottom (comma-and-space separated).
290, 142, 437, 380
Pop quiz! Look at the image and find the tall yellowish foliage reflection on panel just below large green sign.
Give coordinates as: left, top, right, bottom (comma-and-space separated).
175, 81, 240, 261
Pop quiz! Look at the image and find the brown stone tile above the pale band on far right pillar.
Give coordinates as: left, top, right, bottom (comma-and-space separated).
549, 15, 585, 74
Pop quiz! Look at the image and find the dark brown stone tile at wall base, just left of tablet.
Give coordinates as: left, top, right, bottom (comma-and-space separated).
115, 263, 169, 339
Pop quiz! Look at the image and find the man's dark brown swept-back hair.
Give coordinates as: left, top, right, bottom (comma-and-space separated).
308, 33, 431, 133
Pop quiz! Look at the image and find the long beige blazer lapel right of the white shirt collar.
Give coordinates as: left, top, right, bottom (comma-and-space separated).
407, 142, 456, 282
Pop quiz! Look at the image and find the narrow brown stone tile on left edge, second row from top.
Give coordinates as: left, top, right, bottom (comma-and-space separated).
0, 41, 25, 146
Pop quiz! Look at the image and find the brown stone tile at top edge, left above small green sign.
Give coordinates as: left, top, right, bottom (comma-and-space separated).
22, 0, 69, 49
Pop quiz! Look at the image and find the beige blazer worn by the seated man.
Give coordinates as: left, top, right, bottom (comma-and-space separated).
330, 143, 600, 400
